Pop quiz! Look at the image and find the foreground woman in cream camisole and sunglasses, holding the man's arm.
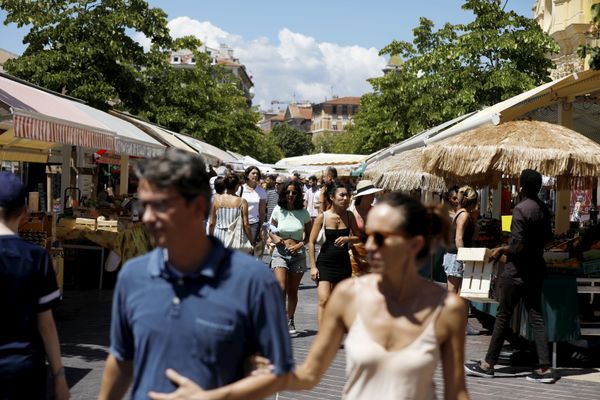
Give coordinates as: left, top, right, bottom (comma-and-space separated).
151, 192, 469, 400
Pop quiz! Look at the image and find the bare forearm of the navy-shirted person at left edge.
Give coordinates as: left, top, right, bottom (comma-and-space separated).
37, 310, 70, 400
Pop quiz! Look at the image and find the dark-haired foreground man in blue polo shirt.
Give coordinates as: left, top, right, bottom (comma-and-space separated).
100, 149, 293, 399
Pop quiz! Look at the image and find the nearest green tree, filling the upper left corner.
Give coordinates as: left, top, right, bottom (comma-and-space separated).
0, 0, 172, 109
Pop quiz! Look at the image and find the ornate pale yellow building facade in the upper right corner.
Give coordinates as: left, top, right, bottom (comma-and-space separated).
533, 0, 600, 79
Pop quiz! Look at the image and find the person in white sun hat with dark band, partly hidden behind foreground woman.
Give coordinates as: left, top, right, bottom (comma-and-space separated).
348, 179, 383, 276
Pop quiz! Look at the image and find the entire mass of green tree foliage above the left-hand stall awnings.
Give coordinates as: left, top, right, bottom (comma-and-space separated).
0, 0, 270, 161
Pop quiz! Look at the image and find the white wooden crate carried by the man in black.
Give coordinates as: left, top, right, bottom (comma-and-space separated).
456, 247, 506, 303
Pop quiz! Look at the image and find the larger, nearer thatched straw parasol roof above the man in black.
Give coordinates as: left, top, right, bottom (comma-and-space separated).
422, 121, 600, 188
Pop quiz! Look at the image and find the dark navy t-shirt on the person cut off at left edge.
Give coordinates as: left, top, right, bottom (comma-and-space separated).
0, 235, 61, 377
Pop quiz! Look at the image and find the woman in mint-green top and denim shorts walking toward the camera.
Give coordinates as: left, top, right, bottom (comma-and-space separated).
269, 181, 311, 334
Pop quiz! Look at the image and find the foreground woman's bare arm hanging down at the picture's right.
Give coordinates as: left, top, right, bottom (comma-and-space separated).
436, 294, 469, 400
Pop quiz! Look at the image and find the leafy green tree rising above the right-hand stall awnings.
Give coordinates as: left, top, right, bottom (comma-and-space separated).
349, 0, 558, 153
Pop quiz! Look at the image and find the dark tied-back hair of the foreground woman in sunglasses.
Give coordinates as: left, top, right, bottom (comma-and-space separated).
377, 192, 450, 260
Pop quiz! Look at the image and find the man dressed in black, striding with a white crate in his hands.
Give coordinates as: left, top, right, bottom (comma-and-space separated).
465, 169, 556, 383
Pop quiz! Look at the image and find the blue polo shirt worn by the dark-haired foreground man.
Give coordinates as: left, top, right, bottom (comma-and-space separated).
110, 238, 294, 399
